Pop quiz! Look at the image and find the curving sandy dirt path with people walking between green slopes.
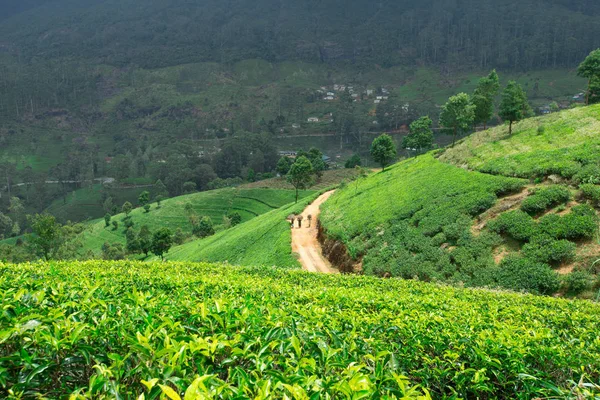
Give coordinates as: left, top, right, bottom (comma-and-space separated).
292, 190, 338, 274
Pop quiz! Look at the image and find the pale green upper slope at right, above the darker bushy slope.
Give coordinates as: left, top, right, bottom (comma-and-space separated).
440, 105, 600, 178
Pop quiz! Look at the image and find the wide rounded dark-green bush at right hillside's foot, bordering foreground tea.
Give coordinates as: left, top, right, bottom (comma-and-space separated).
498, 256, 560, 295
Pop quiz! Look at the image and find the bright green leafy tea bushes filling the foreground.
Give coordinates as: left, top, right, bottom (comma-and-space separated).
0, 262, 600, 400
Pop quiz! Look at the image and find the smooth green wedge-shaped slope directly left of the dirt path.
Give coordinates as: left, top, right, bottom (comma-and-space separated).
162, 192, 315, 268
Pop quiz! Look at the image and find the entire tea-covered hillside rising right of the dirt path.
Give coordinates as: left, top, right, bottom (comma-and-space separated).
322, 106, 600, 297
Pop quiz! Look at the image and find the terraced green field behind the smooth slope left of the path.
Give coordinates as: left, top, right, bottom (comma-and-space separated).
81, 189, 314, 254
